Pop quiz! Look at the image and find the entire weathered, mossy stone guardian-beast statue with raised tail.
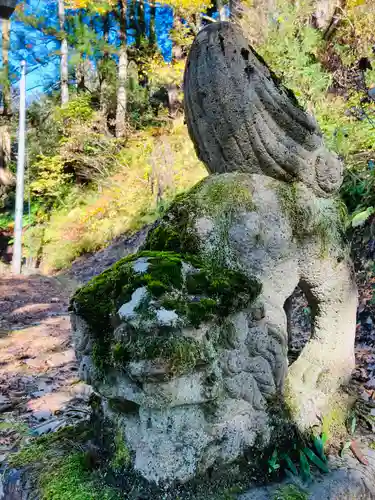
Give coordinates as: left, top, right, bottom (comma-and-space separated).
71, 23, 357, 482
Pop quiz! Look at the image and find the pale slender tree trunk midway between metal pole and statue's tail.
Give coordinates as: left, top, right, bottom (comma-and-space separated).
116, 0, 128, 137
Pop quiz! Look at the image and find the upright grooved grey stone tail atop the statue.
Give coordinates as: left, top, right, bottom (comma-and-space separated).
184, 23, 342, 197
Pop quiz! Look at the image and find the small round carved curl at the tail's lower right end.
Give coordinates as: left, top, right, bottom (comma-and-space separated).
315, 149, 343, 194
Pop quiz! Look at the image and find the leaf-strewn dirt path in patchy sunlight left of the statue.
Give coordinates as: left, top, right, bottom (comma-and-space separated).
0, 276, 90, 460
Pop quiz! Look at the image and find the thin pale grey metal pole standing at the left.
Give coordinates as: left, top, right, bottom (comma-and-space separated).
12, 61, 26, 274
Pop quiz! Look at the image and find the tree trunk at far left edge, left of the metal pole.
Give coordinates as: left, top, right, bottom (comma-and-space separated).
0, 19, 14, 188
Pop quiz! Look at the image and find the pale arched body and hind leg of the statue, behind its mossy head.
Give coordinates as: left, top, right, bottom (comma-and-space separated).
143, 174, 357, 428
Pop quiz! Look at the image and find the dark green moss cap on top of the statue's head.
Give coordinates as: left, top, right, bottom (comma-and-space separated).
71, 251, 261, 375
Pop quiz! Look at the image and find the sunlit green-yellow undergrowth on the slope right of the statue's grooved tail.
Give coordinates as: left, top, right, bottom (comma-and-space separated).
256, 0, 375, 223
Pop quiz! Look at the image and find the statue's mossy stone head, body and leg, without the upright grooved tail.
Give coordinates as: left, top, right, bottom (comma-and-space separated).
73, 174, 356, 482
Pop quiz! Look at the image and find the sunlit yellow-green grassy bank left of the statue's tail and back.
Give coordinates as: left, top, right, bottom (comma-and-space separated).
25, 120, 206, 271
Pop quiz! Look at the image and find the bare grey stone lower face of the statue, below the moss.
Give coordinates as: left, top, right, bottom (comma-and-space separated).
80, 307, 277, 481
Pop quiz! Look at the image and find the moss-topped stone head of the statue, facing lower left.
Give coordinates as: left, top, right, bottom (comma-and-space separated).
72, 248, 276, 482
